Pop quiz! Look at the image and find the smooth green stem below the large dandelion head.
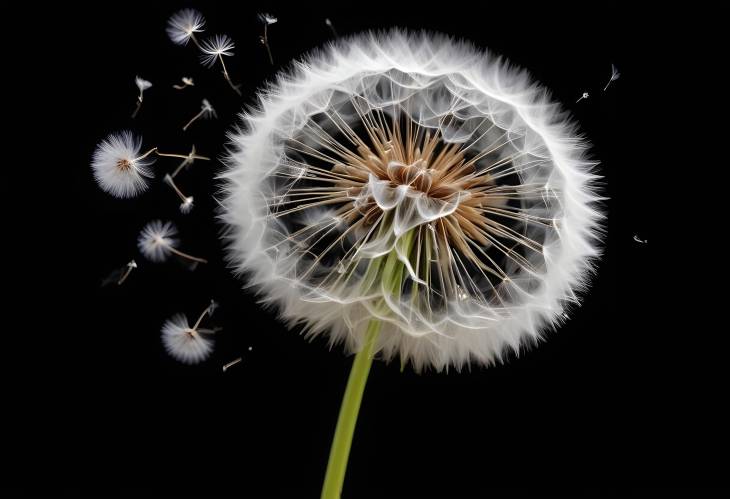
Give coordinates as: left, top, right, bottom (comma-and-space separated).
321, 319, 380, 499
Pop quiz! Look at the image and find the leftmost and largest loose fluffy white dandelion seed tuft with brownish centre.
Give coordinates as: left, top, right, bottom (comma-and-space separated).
91, 131, 156, 198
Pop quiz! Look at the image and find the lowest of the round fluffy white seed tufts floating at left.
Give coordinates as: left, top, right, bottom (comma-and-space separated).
162, 302, 216, 364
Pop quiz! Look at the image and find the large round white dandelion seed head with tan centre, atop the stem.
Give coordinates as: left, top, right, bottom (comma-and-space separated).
221, 31, 603, 370
